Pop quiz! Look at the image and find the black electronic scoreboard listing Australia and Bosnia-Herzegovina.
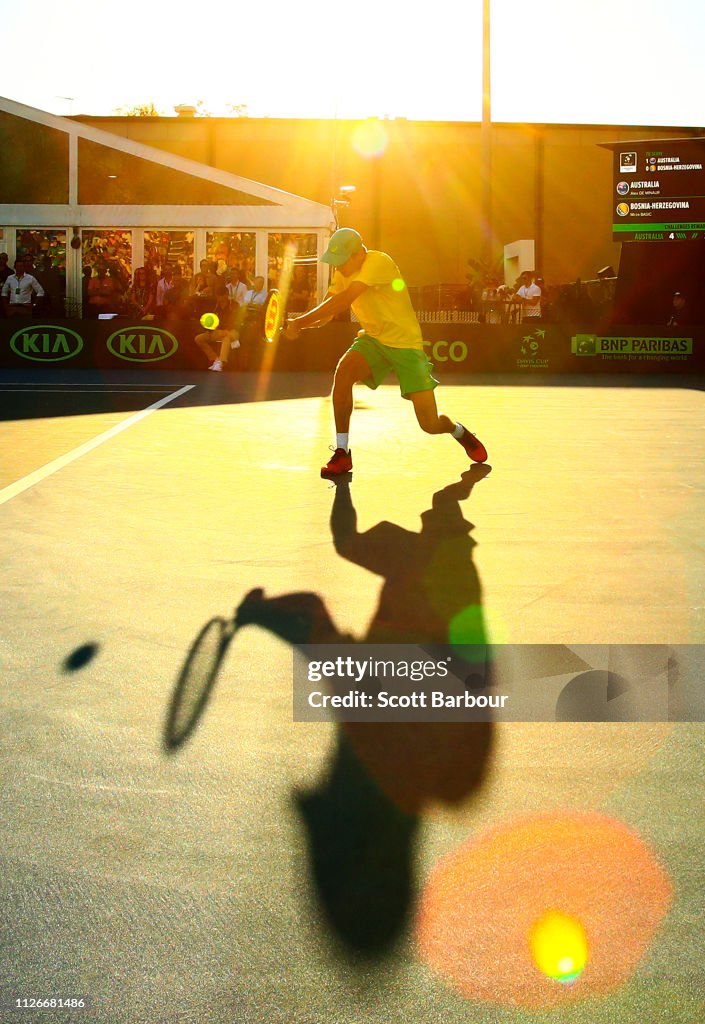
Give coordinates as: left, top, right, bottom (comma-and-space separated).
611, 139, 705, 242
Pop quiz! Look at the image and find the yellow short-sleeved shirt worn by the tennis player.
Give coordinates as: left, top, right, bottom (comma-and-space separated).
328, 250, 423, 349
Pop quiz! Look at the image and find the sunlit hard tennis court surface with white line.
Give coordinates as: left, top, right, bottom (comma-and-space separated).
0, 371, 705, 1024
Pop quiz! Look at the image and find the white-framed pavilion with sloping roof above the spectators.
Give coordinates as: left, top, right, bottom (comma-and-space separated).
0, 97, 332, 303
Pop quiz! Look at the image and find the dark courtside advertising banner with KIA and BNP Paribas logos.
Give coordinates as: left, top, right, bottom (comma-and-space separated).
0, 317, 705, 380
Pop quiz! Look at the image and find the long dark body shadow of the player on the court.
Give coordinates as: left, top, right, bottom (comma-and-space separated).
236, 466, 493, 957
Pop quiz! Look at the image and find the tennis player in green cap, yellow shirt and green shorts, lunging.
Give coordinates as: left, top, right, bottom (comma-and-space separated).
285, 227, 487, 479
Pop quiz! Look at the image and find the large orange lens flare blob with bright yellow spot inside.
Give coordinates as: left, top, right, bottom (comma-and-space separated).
416, 812, 672, 1011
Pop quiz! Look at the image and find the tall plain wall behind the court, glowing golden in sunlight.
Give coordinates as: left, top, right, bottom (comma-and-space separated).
76, 117, 699, 286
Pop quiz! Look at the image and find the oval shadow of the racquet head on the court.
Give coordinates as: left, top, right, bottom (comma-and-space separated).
163, 615, 237, 753
